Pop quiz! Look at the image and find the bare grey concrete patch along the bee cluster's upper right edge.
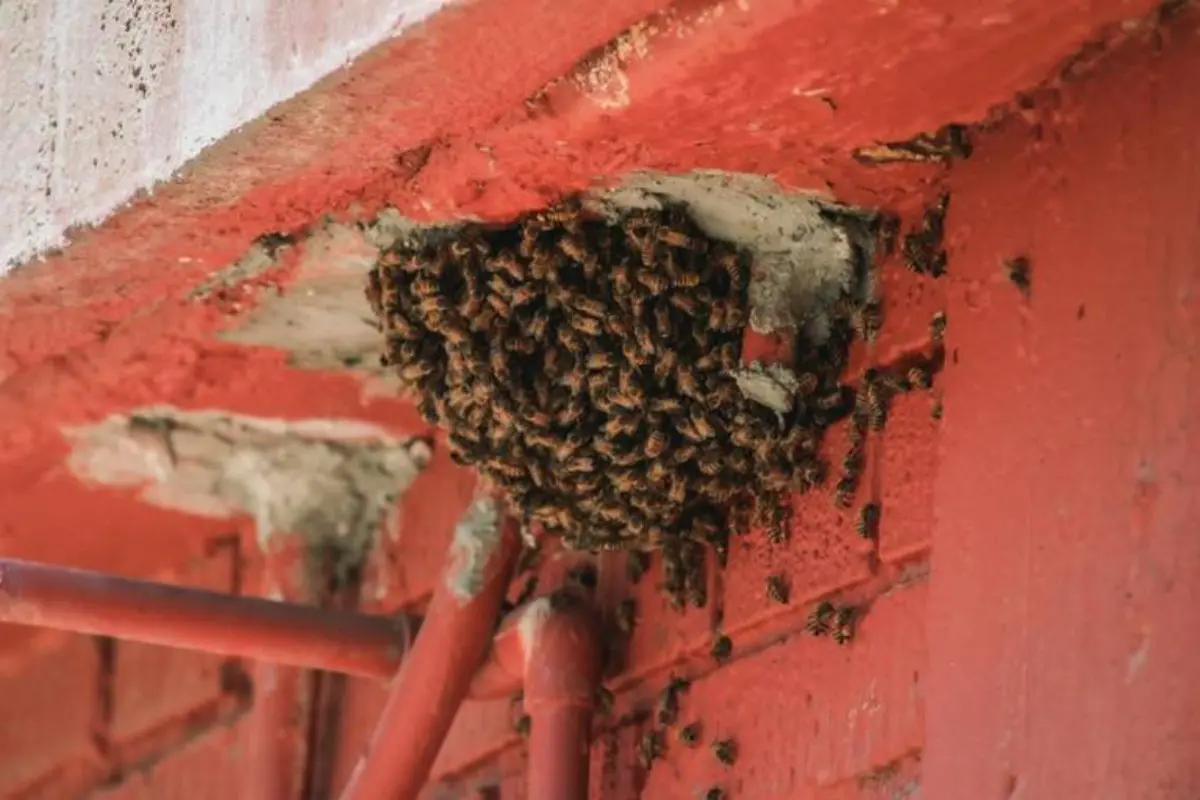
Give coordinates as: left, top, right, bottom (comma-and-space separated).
595, 172, 874, 343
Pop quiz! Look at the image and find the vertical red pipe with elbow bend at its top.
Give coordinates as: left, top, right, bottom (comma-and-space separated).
472, 591, 601, 800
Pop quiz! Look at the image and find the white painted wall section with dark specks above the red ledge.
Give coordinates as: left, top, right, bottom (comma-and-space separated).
0, 0, 443, 273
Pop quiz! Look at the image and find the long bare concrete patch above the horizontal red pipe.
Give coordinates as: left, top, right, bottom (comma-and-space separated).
66, 407, 431, 563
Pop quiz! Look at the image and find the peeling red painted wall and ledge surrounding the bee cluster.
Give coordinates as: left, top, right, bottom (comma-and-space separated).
0, 0, 1200, 800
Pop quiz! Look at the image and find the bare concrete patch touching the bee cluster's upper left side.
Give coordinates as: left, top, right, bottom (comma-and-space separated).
221, 221, 393, 375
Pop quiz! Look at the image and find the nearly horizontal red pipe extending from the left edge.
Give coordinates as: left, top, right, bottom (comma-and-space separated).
0, 559, 414, 678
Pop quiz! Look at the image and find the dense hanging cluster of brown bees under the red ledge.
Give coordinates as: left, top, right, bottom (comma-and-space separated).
367, 197, 854, 608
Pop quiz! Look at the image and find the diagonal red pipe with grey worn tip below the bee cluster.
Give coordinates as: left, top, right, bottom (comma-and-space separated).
342, 498, 521, 800
